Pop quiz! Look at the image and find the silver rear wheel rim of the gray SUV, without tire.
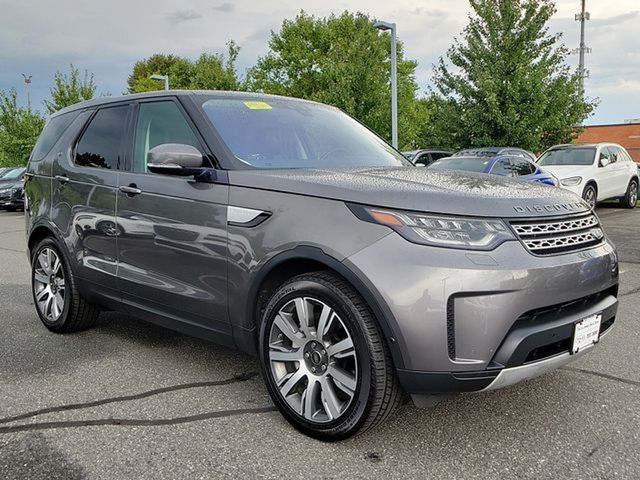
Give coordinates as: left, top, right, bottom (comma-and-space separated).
33, 247, 65, 322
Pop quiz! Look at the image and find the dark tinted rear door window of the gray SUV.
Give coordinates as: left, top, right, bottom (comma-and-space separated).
75, 106, 129, 170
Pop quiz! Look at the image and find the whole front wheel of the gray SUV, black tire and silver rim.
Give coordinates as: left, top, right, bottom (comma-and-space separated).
259, 271, 404, 441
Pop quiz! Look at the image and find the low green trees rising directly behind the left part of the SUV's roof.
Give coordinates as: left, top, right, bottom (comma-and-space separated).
127, 40, 241, 93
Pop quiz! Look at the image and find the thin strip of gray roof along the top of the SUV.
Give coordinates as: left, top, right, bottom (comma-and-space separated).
51, 90, 318, 117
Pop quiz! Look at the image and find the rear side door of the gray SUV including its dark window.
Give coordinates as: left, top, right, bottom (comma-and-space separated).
51, 104, 130, 300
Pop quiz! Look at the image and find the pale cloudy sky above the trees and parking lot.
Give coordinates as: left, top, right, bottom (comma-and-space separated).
0, 0, 640, 124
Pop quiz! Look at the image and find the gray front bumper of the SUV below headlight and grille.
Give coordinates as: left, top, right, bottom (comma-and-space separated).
345, 234, 618, 394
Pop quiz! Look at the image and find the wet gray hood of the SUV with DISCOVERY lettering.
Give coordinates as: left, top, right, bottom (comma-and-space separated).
229, 167, 589, 218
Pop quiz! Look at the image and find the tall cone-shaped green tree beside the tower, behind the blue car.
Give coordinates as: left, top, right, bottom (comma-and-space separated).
425, 0, 596, 151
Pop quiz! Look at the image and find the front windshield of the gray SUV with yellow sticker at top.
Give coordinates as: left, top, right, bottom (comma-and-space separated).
202, 98, 411, 168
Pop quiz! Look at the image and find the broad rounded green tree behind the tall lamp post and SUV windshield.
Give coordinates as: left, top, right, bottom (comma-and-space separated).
247, 12, 426, 147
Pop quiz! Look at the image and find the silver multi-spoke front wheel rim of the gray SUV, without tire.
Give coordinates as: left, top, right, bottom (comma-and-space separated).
268, 297, 358, 423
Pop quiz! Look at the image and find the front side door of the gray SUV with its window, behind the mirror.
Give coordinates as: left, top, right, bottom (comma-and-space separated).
117, 97, 230, 333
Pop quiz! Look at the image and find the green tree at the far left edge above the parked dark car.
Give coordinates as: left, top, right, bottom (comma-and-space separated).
0, 89, 44, 167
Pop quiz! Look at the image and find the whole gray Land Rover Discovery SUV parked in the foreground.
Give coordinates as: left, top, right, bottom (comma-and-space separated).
25, 92, 618, 440
